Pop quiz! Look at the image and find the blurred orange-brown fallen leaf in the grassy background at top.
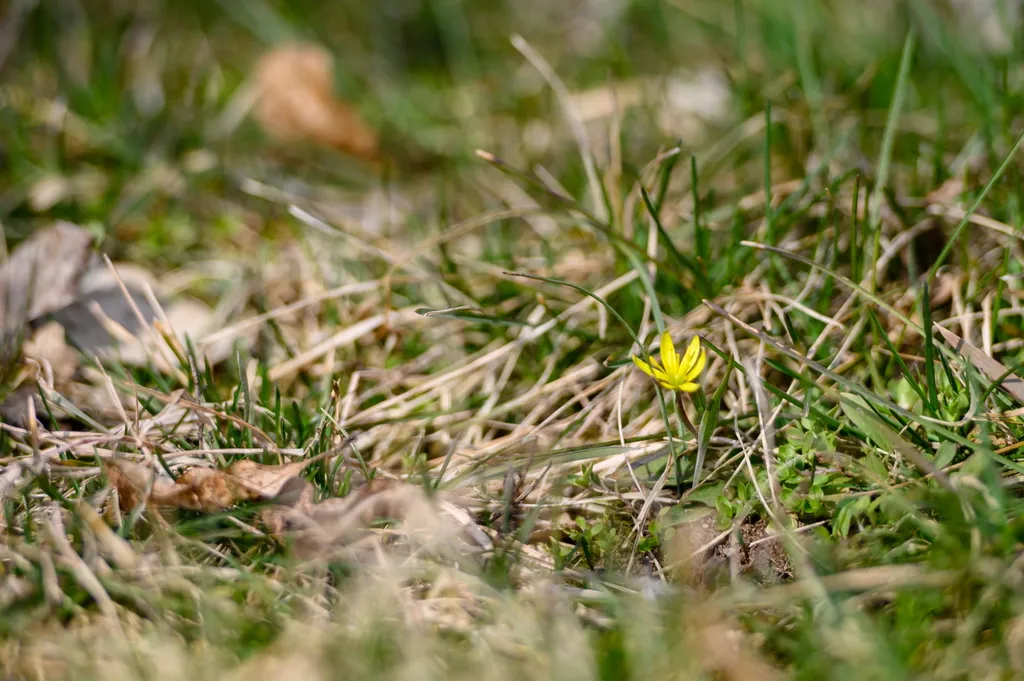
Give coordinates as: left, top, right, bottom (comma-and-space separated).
254, 43, 379, 160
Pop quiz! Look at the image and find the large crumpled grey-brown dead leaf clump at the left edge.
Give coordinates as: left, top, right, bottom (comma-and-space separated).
0, 222, 257, 425
